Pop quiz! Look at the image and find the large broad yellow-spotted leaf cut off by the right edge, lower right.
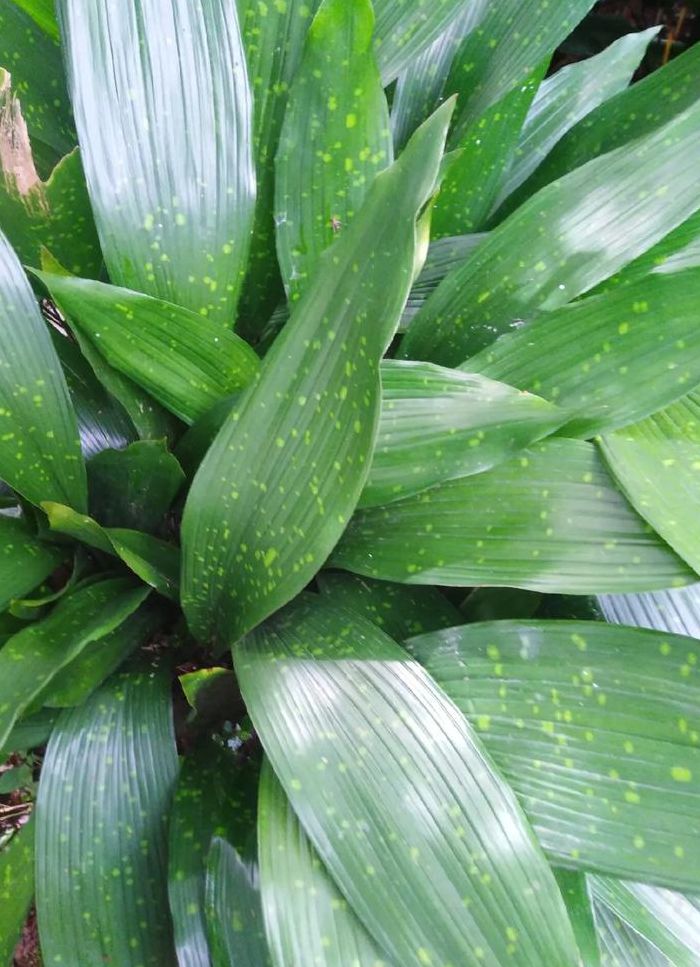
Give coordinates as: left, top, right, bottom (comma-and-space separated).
410, 621, 700, 890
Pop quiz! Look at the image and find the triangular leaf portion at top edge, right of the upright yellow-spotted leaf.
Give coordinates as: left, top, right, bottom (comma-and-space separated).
374, 0, 479, 83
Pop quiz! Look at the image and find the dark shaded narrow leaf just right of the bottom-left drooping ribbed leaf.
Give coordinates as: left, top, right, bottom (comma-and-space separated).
168, 740, 263, 967
